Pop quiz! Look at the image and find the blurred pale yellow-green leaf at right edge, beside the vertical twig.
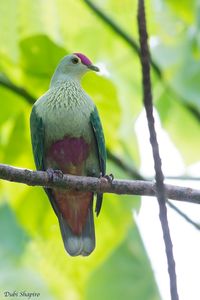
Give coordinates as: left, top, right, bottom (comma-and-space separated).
156, 84, 200, 164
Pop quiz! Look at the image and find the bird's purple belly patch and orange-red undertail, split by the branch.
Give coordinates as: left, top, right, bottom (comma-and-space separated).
46, 137, 93, 234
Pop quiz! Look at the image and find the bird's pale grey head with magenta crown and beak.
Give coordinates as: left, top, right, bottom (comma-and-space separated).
52, 53, 99, 83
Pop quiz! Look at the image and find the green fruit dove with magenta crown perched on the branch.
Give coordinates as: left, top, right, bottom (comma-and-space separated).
30, 53, 106, 256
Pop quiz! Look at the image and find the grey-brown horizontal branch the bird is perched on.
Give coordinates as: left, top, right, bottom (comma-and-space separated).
0, 164, 200, 204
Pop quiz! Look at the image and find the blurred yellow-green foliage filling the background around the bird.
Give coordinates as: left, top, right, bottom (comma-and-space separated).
0, 0, 200, 300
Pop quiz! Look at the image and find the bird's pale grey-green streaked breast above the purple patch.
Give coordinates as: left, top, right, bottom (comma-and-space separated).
35, 83, 94, 147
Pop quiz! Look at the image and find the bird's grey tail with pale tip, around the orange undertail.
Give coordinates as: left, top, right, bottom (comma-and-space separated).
58, 201, 95, 256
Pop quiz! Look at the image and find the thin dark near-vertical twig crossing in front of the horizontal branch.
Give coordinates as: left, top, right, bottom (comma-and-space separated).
138, 0, 179, 300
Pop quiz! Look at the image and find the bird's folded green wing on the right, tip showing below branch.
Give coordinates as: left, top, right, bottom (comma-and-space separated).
90, 107, 106, 215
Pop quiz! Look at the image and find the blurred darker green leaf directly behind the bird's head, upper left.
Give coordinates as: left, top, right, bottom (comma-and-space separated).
20, 35, 68, 94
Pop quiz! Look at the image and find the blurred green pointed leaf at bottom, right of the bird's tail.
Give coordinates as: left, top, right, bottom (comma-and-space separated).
86, 226, 160, 300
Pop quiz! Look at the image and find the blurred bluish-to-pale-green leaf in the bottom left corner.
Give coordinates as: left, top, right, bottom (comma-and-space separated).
0, 204, 54, 300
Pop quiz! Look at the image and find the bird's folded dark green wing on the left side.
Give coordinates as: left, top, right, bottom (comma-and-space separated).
30, 106, 44, 170
